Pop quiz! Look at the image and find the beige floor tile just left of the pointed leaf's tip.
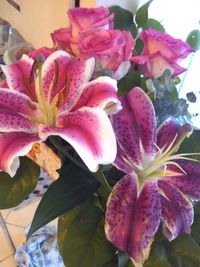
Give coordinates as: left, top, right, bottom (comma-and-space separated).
6, 197, 41, 227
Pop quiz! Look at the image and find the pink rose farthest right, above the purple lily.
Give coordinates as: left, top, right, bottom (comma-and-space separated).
131, 29, 194, 78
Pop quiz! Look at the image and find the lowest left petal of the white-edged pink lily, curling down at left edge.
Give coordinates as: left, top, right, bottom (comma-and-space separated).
0, 133, 40, 177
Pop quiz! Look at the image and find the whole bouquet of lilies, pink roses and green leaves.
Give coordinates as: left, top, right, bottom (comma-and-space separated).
0, 1, 200, 267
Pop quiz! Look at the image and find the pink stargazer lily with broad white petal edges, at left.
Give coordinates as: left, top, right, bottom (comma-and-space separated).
0, 51, 121, 176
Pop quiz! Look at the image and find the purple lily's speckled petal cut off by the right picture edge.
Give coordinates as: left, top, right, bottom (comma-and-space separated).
163, 160, 200, 200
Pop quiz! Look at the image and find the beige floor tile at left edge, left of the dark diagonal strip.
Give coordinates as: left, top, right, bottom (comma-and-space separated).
0, 224, 14, 261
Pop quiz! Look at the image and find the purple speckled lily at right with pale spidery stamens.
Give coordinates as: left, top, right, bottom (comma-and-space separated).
105, 87, 200, 266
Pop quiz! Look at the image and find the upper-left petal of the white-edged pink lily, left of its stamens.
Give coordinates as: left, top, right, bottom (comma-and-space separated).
1, 55, 36, 100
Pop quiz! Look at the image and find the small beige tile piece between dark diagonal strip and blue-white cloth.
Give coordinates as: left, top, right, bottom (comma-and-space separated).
7, 224, 26, 249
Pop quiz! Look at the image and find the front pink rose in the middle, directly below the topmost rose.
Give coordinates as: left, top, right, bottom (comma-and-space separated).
78, 30, 135, 77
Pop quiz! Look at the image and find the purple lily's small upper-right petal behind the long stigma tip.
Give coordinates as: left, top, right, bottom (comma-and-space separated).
157, 118, 192, 151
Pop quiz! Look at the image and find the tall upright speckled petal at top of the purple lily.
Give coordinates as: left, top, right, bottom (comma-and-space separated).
112, 87, 156, 168
